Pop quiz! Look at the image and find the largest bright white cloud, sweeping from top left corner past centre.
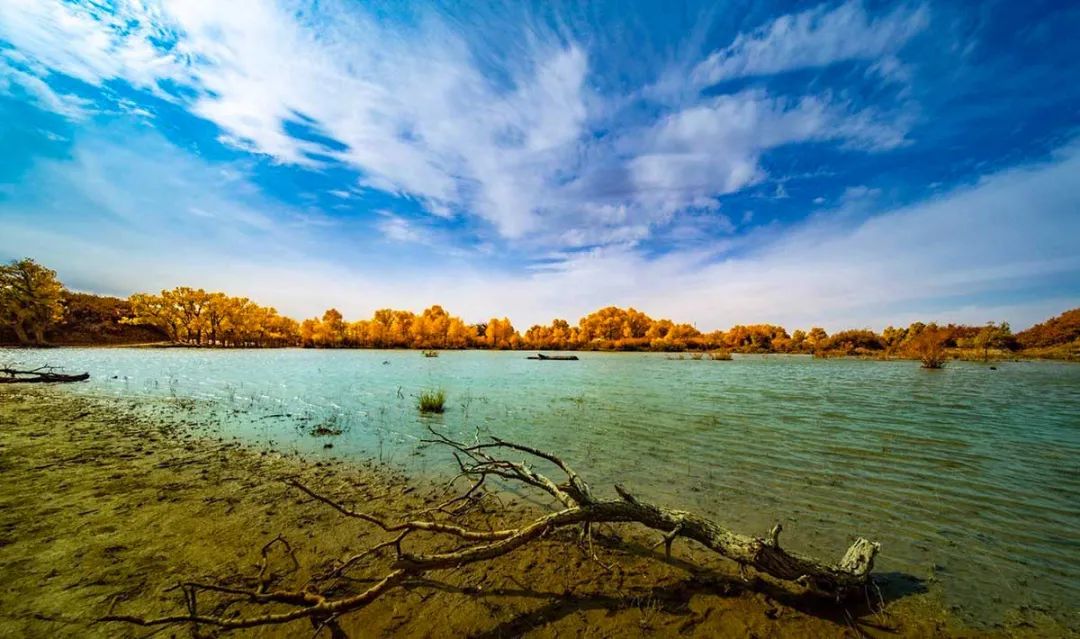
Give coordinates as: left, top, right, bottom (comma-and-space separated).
0, 0, 921, 246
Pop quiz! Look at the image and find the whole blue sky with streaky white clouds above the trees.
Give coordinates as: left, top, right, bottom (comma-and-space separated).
0, 0, 1080, 330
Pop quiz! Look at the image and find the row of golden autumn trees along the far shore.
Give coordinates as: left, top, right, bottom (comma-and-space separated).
0, 258, 1080, 357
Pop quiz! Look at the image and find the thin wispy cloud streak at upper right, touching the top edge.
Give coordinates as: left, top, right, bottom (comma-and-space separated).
692, 0, 929, 85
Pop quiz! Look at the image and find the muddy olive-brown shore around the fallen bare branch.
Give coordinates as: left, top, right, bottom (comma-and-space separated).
0, 386, 1066, 638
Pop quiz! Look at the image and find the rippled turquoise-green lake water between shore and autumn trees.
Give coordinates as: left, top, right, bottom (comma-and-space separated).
0, 349, 1080, 626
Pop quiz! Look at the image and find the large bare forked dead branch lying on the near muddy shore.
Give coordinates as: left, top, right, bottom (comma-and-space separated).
100, 427, 879, 629
